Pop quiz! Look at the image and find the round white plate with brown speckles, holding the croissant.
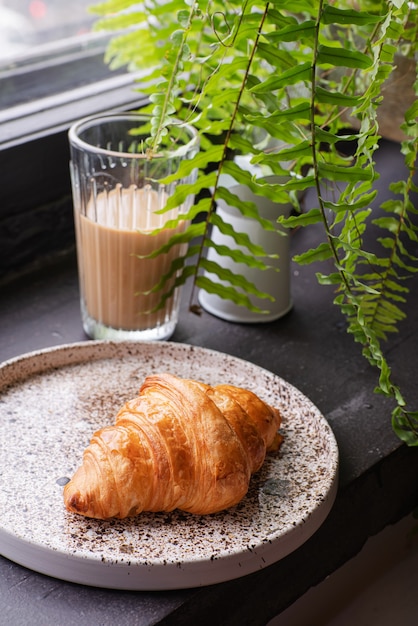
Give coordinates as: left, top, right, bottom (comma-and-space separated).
0, 341, 338, 590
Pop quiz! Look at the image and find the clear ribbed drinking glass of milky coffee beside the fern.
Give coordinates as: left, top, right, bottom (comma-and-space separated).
69, 113, 198, 340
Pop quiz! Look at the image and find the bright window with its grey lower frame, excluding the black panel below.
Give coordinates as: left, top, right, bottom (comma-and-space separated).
0, 0, 147, 148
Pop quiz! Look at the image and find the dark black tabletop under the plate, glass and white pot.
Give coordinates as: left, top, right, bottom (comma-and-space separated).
0, 139, 418, 626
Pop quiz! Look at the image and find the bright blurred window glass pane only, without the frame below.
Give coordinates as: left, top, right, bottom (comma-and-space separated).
0, 0, 122, 112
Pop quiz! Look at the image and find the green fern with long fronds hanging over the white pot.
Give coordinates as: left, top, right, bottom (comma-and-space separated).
90, 0, 418, 445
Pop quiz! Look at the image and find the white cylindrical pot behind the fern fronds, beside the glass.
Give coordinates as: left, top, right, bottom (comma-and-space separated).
199, 177, 292, 323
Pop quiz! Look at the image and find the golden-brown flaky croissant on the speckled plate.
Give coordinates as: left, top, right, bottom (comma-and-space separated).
64, 374, 281, 519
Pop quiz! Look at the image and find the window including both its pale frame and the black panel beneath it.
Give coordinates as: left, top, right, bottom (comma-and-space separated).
0, 0, 143, 282
